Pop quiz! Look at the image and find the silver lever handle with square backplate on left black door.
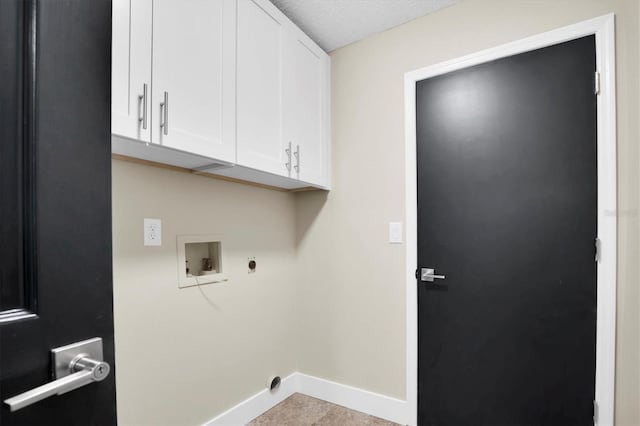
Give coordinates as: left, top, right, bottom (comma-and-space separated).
4, 338, 111, 411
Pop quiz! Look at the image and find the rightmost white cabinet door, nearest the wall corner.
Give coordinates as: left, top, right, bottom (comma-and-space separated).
284, 33, 329, 186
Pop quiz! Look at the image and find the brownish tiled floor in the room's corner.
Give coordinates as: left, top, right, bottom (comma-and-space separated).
248, 393, 398, 426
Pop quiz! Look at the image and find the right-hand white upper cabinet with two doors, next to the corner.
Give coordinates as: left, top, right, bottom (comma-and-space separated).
237, 0, 329, 187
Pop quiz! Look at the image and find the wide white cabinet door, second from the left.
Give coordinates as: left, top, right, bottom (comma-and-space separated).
152, 0, 236, 162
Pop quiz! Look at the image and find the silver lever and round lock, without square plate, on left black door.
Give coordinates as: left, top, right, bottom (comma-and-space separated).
4, 341, 111, 411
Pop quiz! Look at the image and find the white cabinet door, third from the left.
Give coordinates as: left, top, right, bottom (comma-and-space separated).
237, 0, 290, 176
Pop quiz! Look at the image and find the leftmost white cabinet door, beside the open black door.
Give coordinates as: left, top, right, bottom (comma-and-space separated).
111, 0, 152, 142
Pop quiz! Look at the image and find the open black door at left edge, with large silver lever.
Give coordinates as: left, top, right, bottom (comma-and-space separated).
0, 0, 116, 426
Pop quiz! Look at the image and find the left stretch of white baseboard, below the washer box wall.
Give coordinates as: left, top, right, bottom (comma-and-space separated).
203, 373, 298, 426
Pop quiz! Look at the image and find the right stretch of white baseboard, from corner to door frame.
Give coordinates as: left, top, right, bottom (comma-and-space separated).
297, 373, 409, 425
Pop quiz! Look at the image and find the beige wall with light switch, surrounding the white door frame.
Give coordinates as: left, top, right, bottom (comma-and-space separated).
296, 0, 640, 425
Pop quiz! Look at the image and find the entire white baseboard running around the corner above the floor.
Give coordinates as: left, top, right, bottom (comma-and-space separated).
204, 373, 408, 426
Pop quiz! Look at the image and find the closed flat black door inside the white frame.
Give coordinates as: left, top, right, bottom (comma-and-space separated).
416, 36, 597, 426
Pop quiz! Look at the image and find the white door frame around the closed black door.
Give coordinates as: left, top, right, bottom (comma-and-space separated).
404, 14, 617, 426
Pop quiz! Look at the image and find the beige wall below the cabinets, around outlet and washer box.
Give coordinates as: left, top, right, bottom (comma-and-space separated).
113, 161, 297, 425
